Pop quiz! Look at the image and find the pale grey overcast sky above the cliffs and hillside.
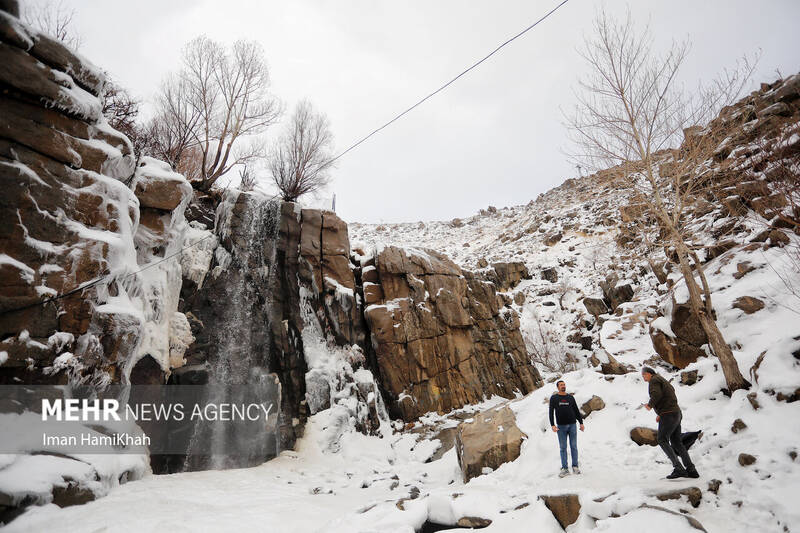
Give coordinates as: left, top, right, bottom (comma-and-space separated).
48, 0, 800, 222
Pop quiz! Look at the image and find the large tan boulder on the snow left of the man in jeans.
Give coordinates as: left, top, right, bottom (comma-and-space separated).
456, 406, 527, 483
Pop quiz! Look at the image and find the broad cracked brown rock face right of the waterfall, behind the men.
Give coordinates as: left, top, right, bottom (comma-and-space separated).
361, 246, 541, 420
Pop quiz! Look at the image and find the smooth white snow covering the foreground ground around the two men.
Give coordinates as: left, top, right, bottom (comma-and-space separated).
6, 359, 800, 532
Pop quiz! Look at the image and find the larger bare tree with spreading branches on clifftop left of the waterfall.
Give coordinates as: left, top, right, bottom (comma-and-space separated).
151, 36, 280, 191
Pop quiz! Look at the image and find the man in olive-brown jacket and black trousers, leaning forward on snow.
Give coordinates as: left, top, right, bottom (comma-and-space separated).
642, 366, 700, 479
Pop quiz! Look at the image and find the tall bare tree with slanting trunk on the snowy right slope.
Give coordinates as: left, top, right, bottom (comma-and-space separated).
567, 7, 752, 392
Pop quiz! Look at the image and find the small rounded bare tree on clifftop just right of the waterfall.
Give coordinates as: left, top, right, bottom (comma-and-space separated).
269, 100, 333, 202
